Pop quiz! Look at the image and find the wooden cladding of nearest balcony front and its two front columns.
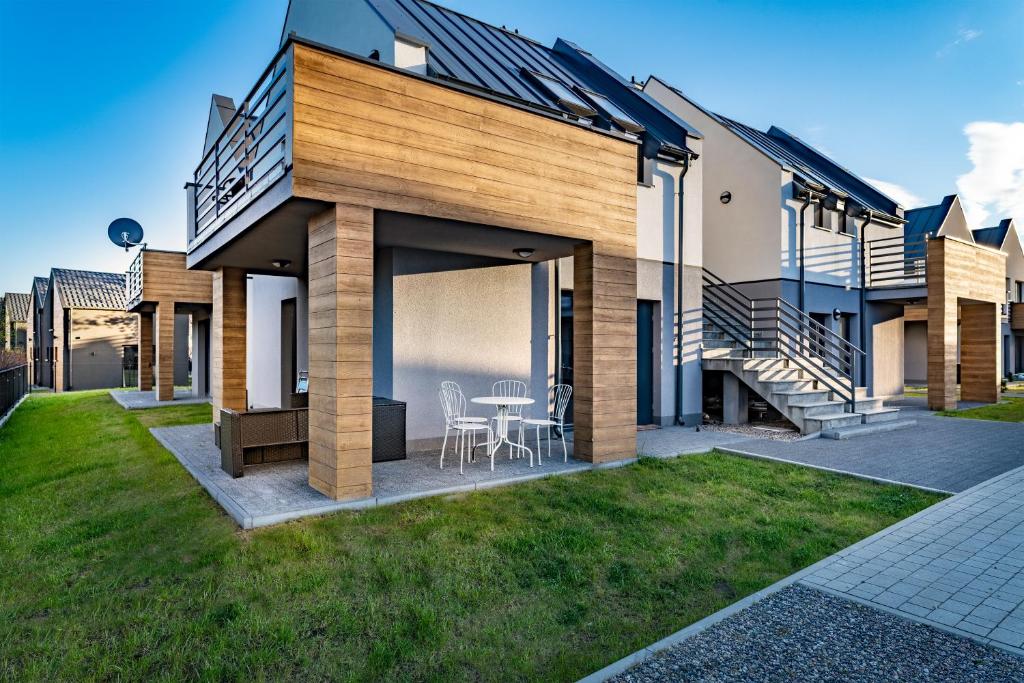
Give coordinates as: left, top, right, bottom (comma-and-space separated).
282, 44, 637, 499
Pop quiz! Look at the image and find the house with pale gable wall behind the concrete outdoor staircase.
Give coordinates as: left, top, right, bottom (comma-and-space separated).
643, 77, 1002, 413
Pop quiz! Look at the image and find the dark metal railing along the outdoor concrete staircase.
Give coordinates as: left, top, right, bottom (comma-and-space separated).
702, 270, 864, 411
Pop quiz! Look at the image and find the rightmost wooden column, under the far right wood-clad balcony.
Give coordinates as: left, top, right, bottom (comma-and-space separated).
961, 303, 1002, 403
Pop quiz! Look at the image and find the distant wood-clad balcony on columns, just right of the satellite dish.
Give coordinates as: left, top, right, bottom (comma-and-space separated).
125, 247, 213, 401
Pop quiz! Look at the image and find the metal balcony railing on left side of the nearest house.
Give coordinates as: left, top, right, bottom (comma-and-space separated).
187, 45, 292, 246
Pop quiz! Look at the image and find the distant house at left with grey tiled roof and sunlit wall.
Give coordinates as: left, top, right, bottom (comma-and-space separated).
36, 268, 137, 391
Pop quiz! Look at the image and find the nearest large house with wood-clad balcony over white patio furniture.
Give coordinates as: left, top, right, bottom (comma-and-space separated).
186, 0, 702, 499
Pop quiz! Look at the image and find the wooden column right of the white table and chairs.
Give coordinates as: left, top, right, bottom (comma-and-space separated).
572, 244, 637, 463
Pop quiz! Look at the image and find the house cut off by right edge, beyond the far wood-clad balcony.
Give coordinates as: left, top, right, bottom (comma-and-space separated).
974, 218, 1024, 375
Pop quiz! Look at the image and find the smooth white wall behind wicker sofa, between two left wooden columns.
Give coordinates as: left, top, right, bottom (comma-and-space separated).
246, 275, 299, 409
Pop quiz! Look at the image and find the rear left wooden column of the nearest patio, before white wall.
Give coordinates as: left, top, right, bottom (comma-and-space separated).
209, 268, 247, 424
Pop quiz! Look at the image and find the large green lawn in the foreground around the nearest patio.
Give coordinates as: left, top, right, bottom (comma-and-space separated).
0, 392, 941, 681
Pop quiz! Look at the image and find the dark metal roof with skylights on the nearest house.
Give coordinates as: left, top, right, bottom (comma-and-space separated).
358, 0, 698, 150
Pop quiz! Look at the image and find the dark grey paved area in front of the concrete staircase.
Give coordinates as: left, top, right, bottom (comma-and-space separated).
725, 410, 1024, 493
